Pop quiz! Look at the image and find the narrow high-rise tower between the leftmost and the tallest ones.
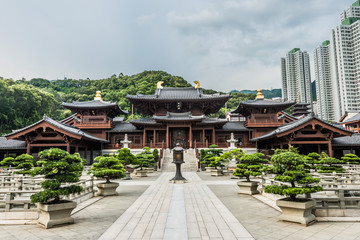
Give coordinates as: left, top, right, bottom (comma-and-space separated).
314, 40, 335, 121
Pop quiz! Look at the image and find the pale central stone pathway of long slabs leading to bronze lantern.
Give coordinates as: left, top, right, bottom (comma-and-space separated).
99, 172, 253, 240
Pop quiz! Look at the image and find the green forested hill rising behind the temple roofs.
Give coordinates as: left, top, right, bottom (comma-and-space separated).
0, 71, 255, 136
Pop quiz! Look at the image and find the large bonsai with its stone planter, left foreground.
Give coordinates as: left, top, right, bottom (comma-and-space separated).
30, 148, 84, 228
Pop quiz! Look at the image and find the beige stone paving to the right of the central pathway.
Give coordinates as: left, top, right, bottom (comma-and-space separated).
209, 179, 360, 240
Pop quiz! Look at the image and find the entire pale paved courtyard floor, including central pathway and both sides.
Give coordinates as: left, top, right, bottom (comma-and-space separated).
0, 172, 360, 240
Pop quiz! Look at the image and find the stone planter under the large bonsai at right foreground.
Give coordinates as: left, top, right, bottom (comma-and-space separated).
276, 198, 316, 226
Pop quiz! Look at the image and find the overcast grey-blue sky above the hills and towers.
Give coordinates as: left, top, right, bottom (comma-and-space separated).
0, 0, 355, 91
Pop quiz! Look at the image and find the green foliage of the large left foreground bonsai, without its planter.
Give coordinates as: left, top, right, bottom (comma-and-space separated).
30, 148, 84, 204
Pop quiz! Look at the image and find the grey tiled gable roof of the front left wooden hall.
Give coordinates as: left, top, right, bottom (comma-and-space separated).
4, 115, 108, 143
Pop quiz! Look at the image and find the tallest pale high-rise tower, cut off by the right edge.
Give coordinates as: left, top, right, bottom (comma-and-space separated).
329, 0, 360, 121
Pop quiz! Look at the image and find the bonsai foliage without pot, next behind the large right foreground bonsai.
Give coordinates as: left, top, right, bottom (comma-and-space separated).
233, 153, 268, 182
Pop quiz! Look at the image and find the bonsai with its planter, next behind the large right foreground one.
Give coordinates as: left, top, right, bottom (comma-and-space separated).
233, 153, 268, 195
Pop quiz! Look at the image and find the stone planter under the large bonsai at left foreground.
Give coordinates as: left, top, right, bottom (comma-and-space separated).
38, 201, 76, 228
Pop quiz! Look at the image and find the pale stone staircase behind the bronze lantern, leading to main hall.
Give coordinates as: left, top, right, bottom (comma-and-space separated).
161, 148, 198, 172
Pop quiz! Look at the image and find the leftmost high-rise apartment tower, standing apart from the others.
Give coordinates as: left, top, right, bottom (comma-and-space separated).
281, 48, 312, 105
